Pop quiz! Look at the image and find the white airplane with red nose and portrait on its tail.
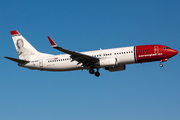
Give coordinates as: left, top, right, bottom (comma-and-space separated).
4, 30, 178, 77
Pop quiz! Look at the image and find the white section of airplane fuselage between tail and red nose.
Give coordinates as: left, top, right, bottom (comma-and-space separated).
19, 46, 135, 71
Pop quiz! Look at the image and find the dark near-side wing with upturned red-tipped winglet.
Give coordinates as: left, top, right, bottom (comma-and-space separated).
48, 36, 99, 66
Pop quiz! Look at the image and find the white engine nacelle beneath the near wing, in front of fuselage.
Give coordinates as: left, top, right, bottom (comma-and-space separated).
99, 58, 117, 67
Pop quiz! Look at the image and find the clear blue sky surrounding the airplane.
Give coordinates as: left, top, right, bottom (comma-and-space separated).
0, 0, 180, 120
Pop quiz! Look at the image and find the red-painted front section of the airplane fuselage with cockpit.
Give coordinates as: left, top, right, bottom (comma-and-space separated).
135, 45, 174, 63
